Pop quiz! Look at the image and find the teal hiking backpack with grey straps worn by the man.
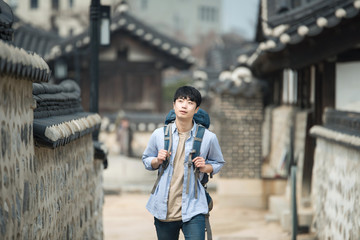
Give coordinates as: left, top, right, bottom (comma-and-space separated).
151, 108, 213, 240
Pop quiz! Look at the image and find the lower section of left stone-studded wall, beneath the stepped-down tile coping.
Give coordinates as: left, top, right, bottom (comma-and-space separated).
31, 135, 104, 239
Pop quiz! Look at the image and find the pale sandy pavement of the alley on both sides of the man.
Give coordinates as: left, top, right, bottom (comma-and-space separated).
103, 156, 291, 240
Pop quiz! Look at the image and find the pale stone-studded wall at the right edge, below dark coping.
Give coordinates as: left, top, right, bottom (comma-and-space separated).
311, 109, 360, 239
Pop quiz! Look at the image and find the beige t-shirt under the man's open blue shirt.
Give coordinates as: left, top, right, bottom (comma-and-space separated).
166, 131, 190, 222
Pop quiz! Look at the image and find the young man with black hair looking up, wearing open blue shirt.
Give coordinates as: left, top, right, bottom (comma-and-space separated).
142, 86, 225, 240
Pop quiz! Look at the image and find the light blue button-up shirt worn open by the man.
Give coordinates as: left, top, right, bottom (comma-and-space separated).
142, 122, 225, 222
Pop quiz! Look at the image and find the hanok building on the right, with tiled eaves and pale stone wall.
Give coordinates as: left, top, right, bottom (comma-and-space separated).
218, 0, 360, 239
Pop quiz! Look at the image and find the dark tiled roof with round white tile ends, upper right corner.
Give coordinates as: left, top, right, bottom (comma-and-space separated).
214, 0, 360, 88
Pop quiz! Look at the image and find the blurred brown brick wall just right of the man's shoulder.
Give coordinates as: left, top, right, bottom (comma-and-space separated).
212, 93, 263, 178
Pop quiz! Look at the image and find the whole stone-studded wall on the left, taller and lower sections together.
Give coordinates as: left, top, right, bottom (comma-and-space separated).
0, 42, 104, 240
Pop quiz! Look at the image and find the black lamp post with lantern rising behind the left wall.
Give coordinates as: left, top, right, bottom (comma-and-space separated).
90, 0, 110, 140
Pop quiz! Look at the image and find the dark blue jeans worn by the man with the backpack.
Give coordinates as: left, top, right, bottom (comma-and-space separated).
154, 214, 205, 240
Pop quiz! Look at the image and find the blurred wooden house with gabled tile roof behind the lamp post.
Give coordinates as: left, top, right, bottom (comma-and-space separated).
46, 6, 194, 113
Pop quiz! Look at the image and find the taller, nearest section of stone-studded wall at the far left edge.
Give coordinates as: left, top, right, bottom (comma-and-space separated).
0, 75, 35, 239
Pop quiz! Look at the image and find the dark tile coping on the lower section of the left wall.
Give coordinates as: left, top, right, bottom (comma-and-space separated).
33, 80, 101, 148
